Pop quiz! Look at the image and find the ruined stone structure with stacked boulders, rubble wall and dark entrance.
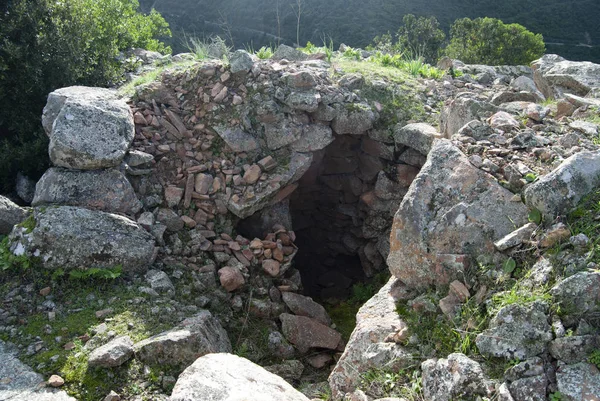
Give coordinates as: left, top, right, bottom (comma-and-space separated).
5, 53, 439, 374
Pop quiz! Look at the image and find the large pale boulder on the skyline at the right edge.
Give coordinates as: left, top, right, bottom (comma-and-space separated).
532, 54, 600, 98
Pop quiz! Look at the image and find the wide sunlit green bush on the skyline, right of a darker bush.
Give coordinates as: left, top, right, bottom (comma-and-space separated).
446, 18, 546, 65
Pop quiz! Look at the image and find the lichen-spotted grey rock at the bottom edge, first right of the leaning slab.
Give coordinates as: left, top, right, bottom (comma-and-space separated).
421, 354, 489, 401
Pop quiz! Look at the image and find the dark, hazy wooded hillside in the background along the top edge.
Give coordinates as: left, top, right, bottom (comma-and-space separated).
140, 0, 600, 62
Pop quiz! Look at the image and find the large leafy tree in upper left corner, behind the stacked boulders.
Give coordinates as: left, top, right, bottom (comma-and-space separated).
0, 0, 170, 192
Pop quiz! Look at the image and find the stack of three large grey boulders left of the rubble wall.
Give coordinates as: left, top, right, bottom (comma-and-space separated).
11, 86, 154, 272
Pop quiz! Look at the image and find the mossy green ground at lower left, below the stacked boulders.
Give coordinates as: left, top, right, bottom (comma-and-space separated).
0, 268, 178, 401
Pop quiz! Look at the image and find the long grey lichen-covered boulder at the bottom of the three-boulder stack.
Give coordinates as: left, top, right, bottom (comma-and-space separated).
10, 206, 154, 273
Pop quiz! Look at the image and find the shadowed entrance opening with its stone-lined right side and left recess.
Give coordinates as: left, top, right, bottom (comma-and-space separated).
237, 135, 418, 304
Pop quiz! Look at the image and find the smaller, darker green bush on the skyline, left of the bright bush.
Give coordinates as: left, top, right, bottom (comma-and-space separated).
397, 14, 446, 63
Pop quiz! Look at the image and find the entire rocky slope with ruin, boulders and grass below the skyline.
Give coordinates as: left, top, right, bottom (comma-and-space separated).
0, 47, 600, 401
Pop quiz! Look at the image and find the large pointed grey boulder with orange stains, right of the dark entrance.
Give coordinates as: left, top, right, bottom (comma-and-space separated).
388, 140, 527, 288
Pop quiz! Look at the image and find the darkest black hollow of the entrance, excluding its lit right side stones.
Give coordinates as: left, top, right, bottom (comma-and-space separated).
290, 135, 389, 303
